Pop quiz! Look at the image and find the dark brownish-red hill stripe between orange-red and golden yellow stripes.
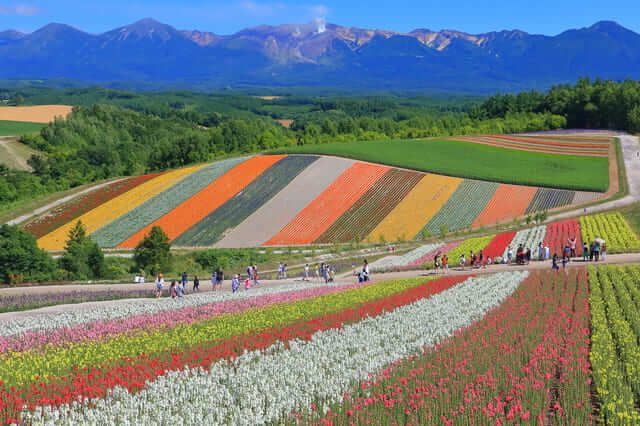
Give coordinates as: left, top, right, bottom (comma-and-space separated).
315, 169, 422, 243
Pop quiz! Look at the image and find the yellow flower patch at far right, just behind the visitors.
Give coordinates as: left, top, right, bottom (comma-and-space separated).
580, 213, 640, 253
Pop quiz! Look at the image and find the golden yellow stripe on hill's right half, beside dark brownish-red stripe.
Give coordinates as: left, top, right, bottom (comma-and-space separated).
368, 174, 462, 241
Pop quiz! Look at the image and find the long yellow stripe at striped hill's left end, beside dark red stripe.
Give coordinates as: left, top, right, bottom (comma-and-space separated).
38, 165, 204, 250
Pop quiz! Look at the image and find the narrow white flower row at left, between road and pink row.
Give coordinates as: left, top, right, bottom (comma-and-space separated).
0, 282, 340, 337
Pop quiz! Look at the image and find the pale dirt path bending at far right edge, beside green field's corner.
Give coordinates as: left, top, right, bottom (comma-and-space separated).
547, 135, 640, 222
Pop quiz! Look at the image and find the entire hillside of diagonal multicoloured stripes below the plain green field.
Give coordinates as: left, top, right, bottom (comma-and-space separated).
24, 151, 616, 251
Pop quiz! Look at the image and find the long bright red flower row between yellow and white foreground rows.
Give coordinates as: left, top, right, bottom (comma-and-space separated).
10, 276, 467, 422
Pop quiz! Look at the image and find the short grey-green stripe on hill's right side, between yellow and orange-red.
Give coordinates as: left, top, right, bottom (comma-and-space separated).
423, 180, 499, 235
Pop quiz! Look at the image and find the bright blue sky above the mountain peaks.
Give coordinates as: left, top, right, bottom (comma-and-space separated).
0, 0, 640, 35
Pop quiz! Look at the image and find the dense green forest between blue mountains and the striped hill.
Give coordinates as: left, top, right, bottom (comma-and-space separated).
0, 80, 640, 211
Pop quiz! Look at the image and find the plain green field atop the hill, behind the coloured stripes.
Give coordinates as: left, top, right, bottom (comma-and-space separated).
272, 139, 609, 192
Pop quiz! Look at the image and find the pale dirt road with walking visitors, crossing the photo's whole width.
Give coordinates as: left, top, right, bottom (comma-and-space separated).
0, 253, 640, 323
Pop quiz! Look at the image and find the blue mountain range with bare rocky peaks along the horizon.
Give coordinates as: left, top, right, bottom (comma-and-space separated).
0, 19, 640, 92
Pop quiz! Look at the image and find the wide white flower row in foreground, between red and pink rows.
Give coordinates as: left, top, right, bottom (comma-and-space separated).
25, 272, 527, 425
